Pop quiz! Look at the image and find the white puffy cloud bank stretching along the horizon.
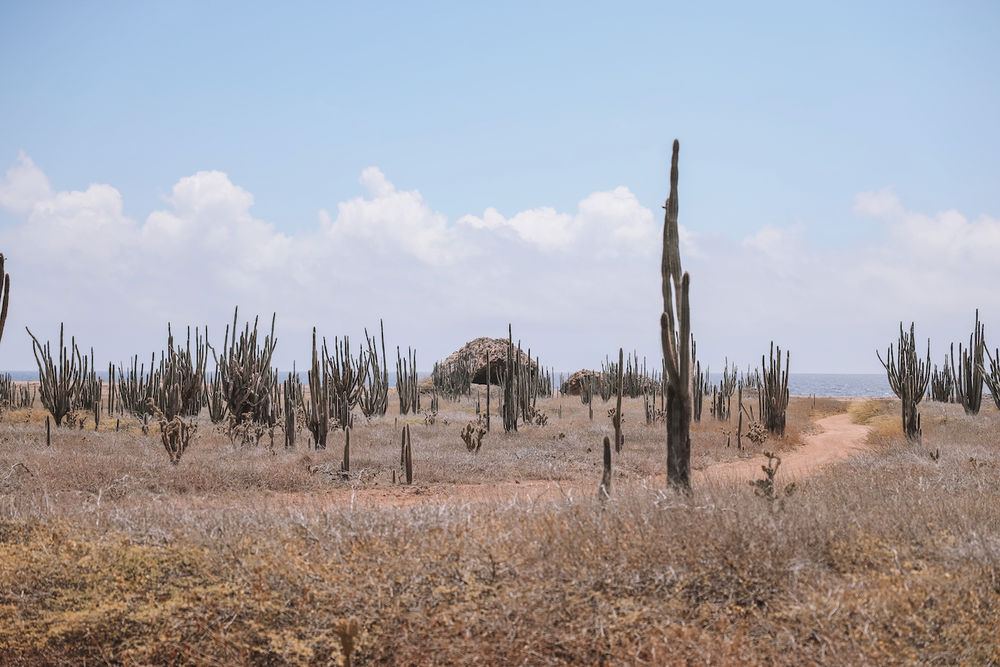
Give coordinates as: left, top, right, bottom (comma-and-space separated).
0, 153, 1000, 372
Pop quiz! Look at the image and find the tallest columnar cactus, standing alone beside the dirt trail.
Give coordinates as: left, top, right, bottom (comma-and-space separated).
660, 139, 691, 490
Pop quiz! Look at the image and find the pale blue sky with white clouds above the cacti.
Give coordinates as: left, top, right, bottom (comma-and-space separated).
0, 2, 1000, 373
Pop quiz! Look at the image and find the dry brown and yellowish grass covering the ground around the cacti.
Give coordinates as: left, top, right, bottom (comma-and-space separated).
0, 388, 1000, 665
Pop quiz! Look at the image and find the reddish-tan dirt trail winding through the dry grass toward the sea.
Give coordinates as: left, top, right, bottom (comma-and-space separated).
256, 415, 868, 507
